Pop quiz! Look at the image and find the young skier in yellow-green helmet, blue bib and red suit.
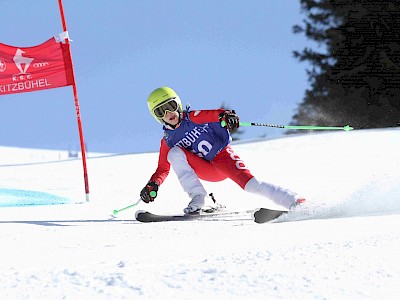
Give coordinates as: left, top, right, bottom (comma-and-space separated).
140, 87, 305, 214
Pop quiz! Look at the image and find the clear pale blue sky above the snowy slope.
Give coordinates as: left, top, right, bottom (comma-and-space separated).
0, 0, 309, 153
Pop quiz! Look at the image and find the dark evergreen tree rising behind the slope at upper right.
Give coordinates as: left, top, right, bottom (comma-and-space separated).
291, 0, 400, 128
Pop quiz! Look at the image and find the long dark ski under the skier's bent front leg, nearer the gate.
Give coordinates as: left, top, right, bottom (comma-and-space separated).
135, 210, 252, 223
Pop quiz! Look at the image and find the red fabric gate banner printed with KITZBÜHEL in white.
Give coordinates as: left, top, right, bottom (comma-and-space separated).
0, 38, 74, 96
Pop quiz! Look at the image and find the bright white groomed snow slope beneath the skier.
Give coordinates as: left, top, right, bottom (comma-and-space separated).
0, 129, 400, 299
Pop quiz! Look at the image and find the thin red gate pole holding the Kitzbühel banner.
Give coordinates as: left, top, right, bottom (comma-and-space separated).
58, 0, 89, 202
